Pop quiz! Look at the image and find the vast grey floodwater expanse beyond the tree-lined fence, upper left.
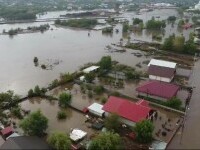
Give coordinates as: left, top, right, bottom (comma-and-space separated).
0, 10, 194, 95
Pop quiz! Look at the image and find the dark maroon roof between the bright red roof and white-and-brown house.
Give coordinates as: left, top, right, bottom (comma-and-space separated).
136, 81, 180, 99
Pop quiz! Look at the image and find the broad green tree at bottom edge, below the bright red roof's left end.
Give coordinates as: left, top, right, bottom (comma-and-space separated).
89, 132, 123, 150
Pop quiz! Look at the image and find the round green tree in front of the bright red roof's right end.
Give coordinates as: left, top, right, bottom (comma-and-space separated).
134, 120, 154, 143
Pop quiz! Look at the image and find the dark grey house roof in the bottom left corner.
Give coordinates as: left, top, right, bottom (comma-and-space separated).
0, 136, 51, 150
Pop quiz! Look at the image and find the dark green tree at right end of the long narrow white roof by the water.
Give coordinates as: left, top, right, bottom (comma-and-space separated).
99, 56, 112, 70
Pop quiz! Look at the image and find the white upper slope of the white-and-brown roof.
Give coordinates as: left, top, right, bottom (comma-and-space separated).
148, 59, 176, 68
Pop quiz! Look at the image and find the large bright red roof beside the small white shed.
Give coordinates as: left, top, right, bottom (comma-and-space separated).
102, 96, 151, 122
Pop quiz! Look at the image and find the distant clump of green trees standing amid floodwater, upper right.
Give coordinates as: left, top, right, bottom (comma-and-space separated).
146, 17, 166, 29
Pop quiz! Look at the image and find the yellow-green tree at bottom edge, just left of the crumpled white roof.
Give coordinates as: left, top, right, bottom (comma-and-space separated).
47, 132, 71, 150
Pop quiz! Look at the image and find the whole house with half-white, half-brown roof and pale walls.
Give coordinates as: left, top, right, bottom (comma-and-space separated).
148, 59, 176, 82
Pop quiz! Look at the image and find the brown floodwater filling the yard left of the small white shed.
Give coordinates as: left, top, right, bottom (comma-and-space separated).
21, 98, 96, 136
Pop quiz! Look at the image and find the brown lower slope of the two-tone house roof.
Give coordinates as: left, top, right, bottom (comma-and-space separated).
148, 65, 176, 78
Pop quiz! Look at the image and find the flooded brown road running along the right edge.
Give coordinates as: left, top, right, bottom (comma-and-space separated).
168, 61, 200, 149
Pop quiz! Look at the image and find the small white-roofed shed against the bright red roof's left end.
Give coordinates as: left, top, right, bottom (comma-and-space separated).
88, 103, 105, 117
